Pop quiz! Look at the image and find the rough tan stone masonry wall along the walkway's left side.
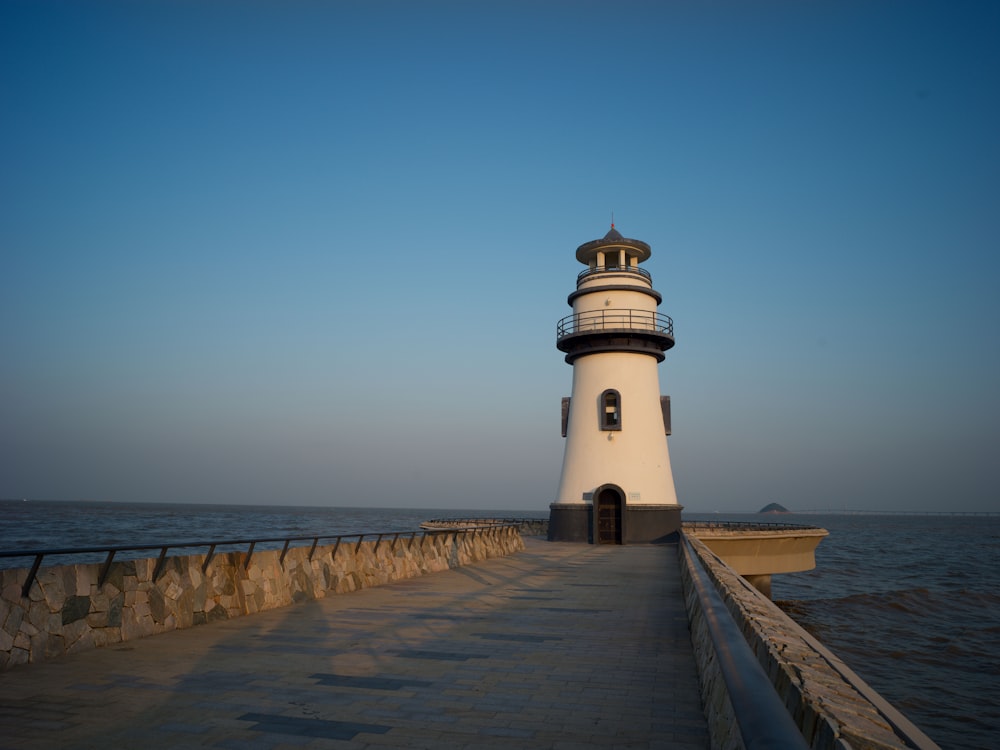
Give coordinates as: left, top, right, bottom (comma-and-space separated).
0, 526, 524, 669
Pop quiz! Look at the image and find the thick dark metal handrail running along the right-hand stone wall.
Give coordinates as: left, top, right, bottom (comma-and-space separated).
681, 534, 809, 750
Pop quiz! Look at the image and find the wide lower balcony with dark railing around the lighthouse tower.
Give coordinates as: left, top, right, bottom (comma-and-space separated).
556, 308, 674, 364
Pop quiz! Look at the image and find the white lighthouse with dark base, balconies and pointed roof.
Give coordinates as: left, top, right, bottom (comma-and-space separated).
549, 224, 681, 544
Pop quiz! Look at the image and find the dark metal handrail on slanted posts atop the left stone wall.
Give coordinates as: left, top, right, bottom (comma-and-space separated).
0, 519, 517, 597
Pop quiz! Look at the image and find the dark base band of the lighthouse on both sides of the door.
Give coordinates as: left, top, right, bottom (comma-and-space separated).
548, 503, 683, 544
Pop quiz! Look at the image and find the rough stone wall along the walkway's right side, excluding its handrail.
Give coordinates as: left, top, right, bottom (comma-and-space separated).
681, 536, 937, 750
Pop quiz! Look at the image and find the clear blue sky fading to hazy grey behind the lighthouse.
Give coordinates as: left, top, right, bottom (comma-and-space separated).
0, 0, 1000, 512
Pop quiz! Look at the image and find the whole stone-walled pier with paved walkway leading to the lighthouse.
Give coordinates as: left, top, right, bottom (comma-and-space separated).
0, 519, 937, 750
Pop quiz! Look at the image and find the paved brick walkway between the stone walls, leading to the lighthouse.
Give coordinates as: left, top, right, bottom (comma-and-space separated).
0, 539, 708, 750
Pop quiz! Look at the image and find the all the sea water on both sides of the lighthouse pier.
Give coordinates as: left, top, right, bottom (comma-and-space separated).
0, 501, 1000, 748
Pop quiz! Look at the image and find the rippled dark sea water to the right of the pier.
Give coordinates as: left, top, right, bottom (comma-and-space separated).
772, 514, 1000, 749
